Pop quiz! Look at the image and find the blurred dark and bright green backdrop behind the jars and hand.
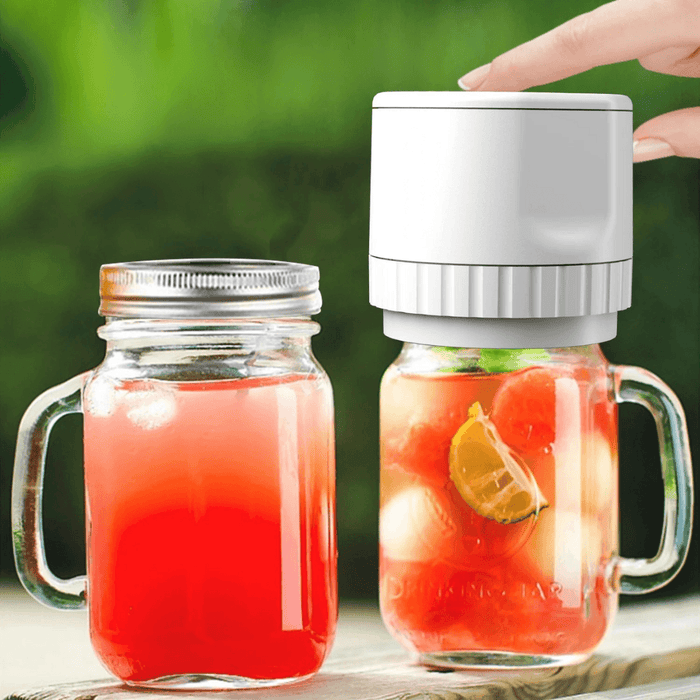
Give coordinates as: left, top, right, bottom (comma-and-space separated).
0, 0, 700, 598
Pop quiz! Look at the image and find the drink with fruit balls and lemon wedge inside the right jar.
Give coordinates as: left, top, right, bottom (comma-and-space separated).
380, 344, 617, 667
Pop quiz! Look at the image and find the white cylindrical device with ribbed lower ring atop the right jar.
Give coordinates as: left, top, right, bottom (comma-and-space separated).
370, 93, 632, 347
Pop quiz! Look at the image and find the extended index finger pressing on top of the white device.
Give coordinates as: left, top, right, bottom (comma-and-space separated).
459, 0, 700, 91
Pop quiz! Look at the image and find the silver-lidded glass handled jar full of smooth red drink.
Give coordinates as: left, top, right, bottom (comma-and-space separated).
12, 260, 337, 689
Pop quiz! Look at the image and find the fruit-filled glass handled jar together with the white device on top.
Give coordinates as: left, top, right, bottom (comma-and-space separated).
370, 93, 693, 668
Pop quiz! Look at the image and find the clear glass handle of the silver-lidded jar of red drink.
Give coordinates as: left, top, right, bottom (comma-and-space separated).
12, 372, 89, 610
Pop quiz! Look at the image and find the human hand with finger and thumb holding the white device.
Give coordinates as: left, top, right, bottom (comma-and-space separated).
458, 0, 700, 162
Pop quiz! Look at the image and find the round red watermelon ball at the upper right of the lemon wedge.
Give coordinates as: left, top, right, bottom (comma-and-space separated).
490, 367, 567, 459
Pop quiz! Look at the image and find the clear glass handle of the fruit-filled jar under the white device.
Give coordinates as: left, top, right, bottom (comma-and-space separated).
610, 365, 693, 594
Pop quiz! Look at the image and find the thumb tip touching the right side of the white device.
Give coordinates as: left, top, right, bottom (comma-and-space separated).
634, 107, 700, 163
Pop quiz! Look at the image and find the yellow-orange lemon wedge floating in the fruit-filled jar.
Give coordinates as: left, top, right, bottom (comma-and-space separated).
450, 401, 549, 523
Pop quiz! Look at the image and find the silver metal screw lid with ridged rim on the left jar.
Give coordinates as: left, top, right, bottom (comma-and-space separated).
99, 258, 321, 319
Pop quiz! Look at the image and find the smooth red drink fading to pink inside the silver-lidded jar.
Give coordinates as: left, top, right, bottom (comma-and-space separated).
85, 375, 337, 682
